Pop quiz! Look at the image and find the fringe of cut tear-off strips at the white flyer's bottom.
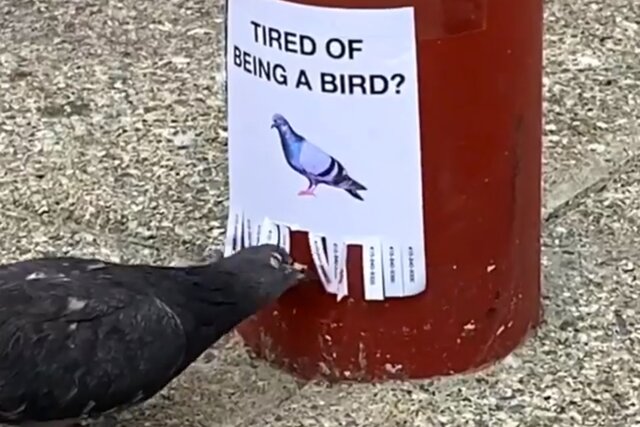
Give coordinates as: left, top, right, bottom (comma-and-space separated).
224, 207, 426, 302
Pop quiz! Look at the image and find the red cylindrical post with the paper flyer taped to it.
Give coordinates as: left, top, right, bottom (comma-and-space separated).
232, 0, 543, 380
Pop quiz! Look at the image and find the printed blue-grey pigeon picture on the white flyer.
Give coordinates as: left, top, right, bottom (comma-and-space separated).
271, 114, 367, 200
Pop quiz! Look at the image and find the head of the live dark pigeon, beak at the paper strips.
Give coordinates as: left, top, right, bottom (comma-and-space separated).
218, 245, 306, 306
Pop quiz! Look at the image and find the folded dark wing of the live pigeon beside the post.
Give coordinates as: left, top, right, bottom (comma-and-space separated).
0, 260, 185, 423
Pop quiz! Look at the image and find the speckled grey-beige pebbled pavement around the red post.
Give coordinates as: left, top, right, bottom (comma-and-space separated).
0, 0, 640, 427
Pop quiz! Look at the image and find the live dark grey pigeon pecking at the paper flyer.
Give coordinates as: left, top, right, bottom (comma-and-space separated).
0, 245, 304, 426
